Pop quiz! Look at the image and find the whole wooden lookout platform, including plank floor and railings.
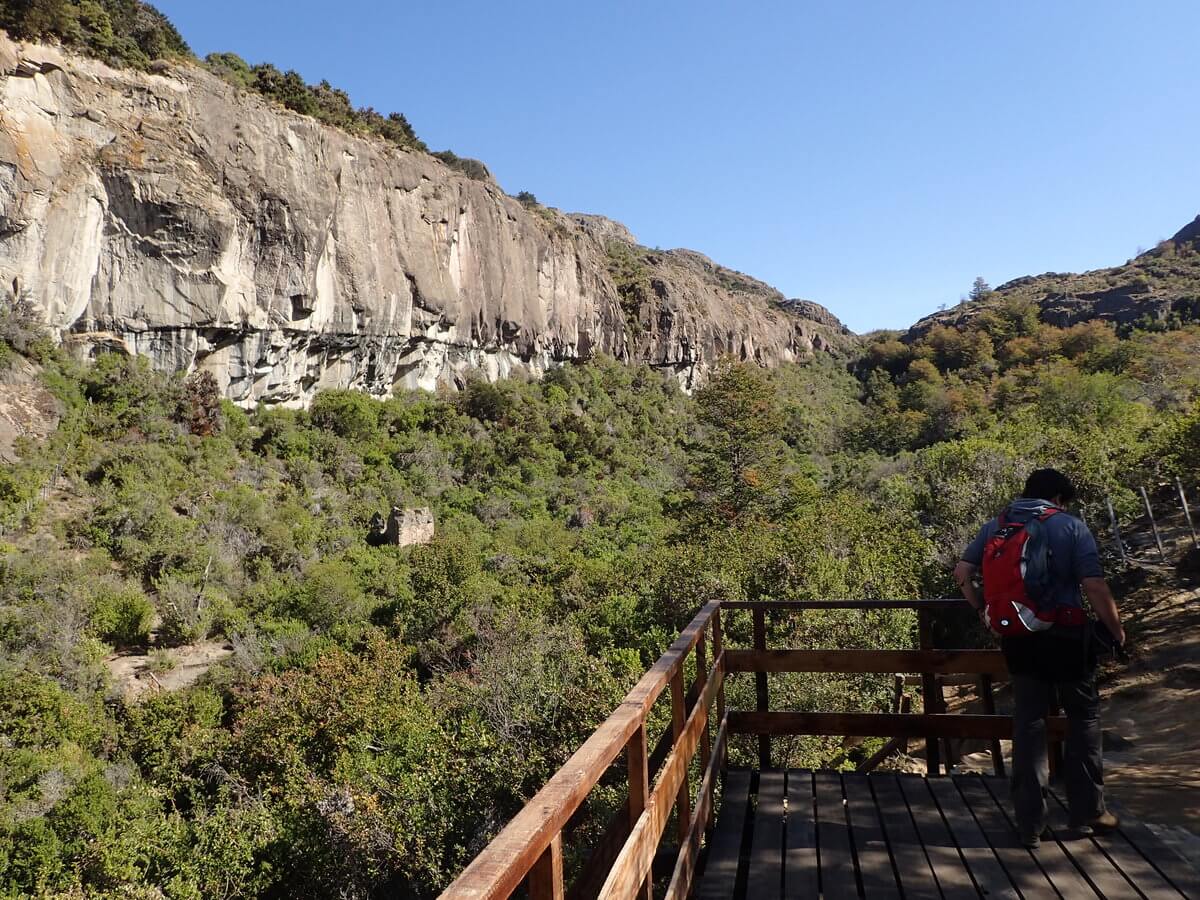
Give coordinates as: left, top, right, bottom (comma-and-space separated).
443, 600, 1200, 900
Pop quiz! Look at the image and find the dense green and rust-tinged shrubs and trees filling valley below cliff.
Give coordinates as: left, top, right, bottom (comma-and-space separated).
0, 271, 1200, 896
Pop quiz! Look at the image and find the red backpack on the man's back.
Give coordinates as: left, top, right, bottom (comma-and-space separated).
983, 506, 1085, 637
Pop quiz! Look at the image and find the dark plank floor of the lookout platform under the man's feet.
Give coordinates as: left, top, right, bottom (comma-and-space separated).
695, 769, 1200, 900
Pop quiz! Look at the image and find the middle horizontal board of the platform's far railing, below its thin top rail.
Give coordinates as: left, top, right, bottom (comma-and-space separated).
726, 649, 1008, 677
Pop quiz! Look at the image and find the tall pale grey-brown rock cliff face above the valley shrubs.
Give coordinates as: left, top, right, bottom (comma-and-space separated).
0, 32, 851, 404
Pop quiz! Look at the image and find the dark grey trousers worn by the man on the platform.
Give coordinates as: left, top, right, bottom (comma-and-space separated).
1012, 672, 1104, 834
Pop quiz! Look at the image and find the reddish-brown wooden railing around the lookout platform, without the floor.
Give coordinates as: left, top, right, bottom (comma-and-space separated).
442, 600, 1066, 900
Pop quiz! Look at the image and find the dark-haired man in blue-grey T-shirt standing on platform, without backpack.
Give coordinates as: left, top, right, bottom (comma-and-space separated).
954, 469, 1124, 850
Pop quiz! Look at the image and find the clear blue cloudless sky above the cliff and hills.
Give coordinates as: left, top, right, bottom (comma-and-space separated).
156, 0, 1200, 331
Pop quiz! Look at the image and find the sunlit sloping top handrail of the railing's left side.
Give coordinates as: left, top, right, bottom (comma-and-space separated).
442, 600, 720, 900
